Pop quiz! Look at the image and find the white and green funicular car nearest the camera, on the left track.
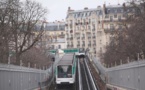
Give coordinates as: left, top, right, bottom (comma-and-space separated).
55, 53, 76, 85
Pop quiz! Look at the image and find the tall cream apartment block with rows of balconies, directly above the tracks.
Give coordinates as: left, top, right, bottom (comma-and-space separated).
65, 6, 103, 56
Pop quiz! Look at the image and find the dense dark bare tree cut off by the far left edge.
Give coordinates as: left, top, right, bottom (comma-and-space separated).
0, 0, 18, 63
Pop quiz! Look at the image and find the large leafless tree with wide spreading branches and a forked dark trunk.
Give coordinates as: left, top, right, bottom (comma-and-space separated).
0, 0, 47, 64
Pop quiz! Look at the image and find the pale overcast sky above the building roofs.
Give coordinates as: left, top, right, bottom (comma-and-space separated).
35, 0, 125, 22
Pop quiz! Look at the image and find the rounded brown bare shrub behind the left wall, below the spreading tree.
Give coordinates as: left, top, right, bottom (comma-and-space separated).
21, 47, 51, 68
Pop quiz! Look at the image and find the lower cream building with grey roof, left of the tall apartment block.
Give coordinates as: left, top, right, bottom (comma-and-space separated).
44, 21, 66, 49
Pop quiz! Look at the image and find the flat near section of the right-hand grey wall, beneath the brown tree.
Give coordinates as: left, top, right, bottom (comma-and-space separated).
107, 60, 145, 90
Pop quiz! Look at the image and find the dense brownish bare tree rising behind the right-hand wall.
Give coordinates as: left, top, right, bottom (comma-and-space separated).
103, 0, 145, 64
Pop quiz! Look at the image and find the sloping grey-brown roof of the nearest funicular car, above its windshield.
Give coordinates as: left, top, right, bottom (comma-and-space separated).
58, 53, 74, 65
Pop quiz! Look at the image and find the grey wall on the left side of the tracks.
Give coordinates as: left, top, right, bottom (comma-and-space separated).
0, 64, 48, 90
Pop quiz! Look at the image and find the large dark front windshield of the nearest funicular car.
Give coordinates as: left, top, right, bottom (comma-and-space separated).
57, 65, 72, 78
